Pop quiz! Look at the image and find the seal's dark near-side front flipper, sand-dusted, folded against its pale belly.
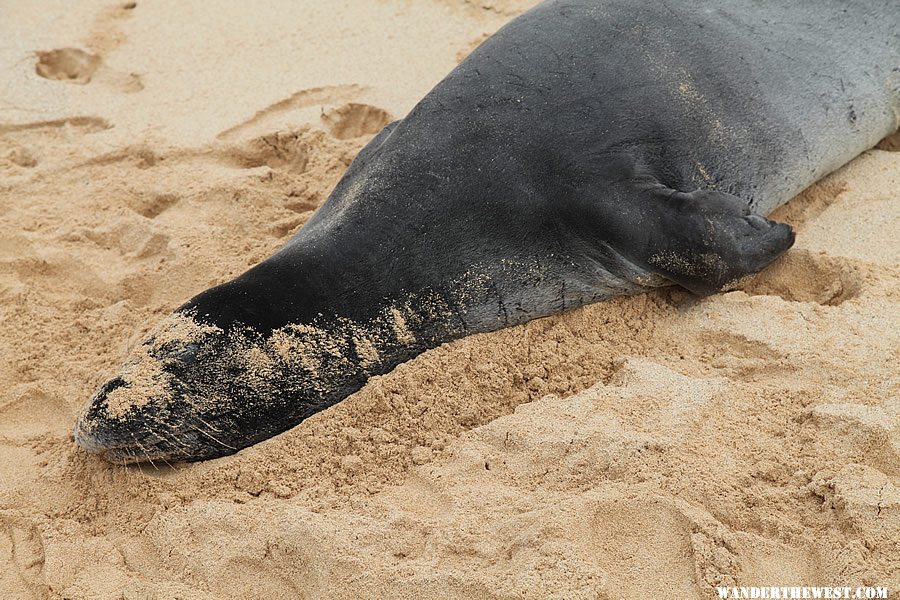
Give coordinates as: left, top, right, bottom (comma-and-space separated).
644, 186, 794, 295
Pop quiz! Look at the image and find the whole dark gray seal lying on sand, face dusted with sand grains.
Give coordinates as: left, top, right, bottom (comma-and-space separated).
75, 0, 900, 462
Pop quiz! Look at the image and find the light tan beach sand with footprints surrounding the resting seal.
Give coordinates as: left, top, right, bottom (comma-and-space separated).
0, 0, 900, 599
